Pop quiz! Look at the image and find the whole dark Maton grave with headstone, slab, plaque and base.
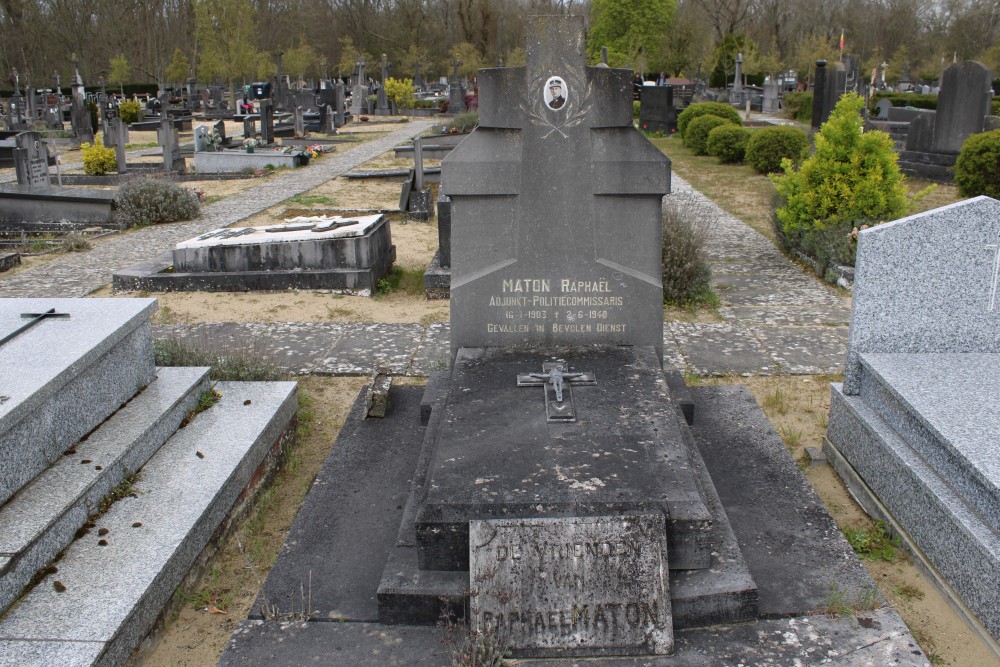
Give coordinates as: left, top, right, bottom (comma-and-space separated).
220, 16, 928, 666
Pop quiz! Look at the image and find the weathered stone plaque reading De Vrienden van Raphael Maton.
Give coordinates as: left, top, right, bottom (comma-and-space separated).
469, 513, 674, 657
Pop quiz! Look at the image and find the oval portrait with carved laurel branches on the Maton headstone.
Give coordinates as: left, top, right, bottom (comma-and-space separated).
520, 69, 593, 139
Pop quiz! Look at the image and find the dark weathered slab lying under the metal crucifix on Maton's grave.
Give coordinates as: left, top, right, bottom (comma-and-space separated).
416, 347, 712, 570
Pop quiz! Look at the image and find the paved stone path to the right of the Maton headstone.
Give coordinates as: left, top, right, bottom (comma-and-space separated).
664, 174, 851, 375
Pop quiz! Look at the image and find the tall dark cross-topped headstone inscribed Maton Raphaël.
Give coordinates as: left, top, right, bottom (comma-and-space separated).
441, 16, 670, 357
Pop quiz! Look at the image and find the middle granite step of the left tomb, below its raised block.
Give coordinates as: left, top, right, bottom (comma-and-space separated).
0, 368, 209, 611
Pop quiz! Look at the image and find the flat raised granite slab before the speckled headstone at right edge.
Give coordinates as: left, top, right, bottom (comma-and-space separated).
860, 353, 1000, 531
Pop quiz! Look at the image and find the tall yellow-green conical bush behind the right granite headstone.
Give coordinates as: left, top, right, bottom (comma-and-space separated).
771, 93, 907, 264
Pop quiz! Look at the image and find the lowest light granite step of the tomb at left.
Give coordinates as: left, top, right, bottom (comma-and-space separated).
0, 382, 297, 666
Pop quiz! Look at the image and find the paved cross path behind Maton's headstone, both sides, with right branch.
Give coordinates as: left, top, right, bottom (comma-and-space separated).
148, 175, 850, 375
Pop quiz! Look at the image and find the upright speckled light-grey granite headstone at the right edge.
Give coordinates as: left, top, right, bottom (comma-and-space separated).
844, 197, 1000, 394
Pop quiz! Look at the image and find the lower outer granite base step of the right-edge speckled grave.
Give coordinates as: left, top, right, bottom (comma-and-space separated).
824, 384, 1000, 637
